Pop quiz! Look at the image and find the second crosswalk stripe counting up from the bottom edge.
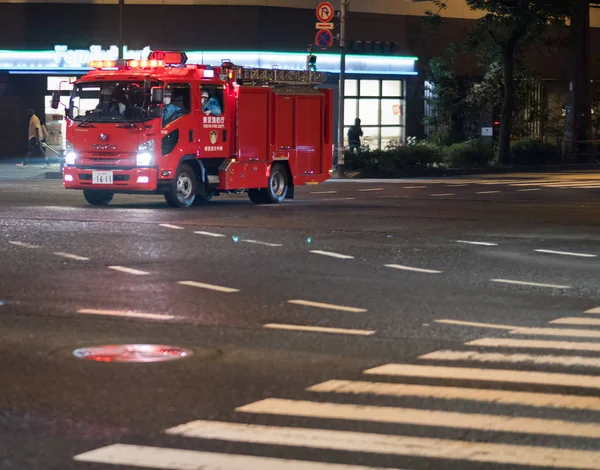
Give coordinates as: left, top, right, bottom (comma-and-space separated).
167, 421, 600, 470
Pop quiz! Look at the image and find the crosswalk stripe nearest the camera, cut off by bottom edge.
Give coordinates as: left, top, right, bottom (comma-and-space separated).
73, 444, 384, 470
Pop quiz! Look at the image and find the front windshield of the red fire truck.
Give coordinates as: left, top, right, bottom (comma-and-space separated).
68, 81, 155, 122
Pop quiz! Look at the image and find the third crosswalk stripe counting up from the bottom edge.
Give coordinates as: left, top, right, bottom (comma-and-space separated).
236, 398, 600, 439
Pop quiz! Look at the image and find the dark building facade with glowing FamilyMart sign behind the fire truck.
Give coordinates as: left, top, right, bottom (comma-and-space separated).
0, 0, 600, 157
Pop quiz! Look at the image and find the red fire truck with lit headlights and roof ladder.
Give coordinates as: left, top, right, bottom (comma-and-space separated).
53, 51, 333, 207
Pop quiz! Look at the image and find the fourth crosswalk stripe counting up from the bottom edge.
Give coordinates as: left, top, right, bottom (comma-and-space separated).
306, 380, 600, 411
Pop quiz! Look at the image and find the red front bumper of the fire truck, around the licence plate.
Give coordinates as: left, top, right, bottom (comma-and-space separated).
63, 166, 158, 193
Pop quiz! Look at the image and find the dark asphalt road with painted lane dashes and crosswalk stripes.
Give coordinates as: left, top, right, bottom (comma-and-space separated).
0, 173, 600, 470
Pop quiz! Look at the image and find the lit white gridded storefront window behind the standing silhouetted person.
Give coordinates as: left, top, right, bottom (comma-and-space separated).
344, 79, 406, 149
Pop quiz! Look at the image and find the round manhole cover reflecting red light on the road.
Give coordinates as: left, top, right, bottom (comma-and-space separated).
73, 344, 193, 362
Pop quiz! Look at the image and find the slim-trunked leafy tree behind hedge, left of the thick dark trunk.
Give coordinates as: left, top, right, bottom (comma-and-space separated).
427, 0, 572, 164
